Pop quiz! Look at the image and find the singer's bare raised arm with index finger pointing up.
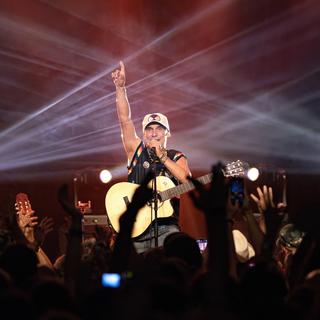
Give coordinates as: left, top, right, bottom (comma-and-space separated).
111, 61, 141, 160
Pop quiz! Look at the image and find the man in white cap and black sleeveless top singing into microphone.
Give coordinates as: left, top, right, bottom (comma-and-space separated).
112, 62, 191, 253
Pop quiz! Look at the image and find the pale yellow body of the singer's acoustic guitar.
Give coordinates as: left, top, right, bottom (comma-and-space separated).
105, 176, 175, 238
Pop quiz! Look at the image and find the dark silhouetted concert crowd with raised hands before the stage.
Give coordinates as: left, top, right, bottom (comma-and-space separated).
0, 164, 320, 320
